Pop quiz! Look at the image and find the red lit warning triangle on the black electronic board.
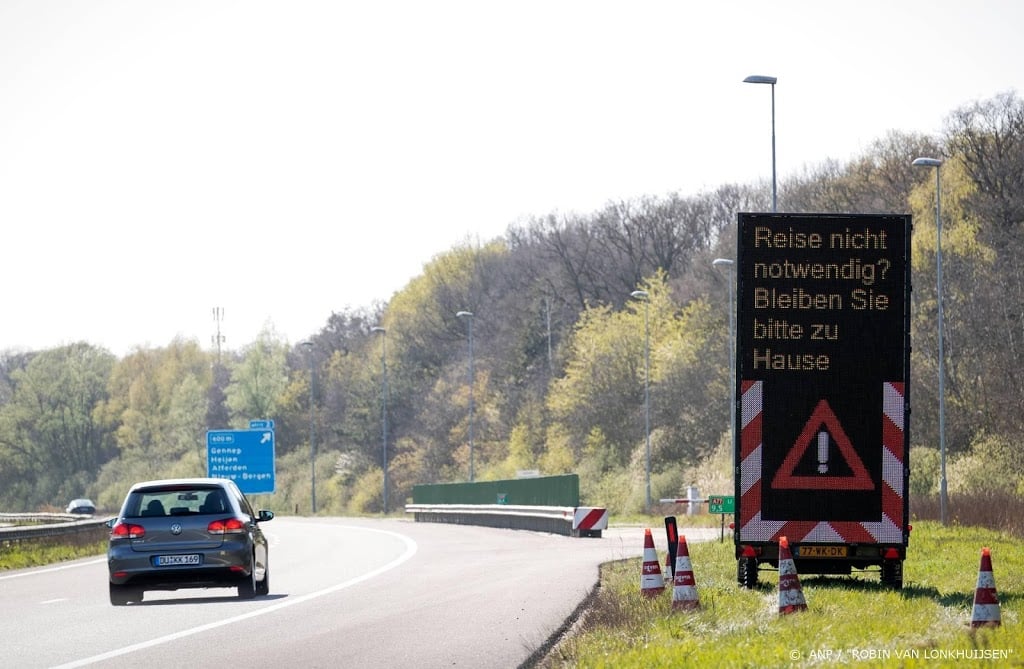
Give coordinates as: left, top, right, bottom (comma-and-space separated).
771, 400, 874, 490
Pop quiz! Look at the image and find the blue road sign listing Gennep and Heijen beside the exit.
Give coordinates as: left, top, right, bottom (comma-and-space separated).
206, 429, 274, 495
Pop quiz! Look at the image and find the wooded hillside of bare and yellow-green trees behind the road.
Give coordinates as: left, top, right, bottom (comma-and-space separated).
0, 92, 1024, 514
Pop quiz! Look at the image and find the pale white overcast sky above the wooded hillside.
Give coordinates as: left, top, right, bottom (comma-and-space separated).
0, 0, 1024, 357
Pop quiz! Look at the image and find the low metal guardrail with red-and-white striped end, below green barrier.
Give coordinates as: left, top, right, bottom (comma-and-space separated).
406, 504, 608, 537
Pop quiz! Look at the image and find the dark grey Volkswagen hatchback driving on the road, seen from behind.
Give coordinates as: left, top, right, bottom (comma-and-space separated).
106, 478, 273, 605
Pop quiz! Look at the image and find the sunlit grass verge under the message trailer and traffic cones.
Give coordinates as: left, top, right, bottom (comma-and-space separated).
537, 521, 1024, 669
